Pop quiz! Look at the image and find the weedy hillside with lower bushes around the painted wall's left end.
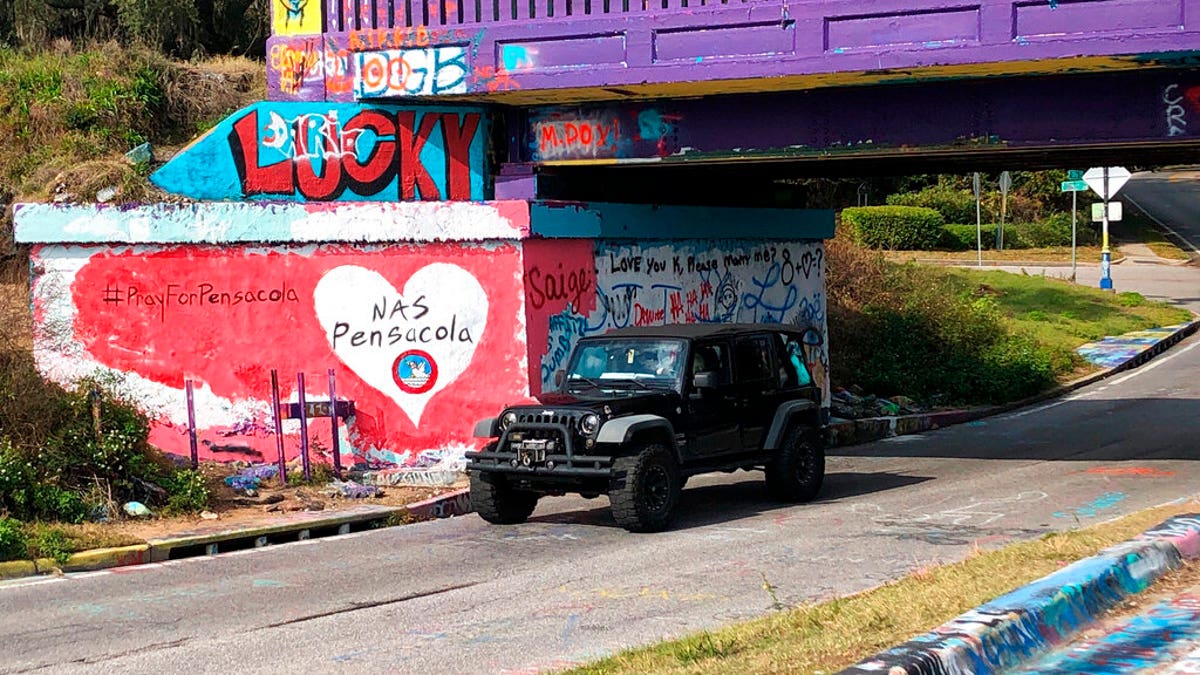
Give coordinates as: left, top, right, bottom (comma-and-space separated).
0, 41, 265, 560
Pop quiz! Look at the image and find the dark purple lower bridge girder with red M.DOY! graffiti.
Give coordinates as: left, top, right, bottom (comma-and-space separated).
520, 68, 1200, 163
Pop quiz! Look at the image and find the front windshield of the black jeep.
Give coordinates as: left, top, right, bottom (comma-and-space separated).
563, 338, 688, 393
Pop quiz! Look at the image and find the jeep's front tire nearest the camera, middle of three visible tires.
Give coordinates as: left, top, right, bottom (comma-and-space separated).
608, 443, 683, 532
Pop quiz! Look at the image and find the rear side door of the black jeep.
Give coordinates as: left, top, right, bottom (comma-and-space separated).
733, 334, 779, 450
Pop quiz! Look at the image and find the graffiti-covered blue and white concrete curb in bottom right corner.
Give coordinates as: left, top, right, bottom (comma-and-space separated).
841, 514, 1200, 675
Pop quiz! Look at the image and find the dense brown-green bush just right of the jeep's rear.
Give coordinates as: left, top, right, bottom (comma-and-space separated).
827, 240, 1060, 404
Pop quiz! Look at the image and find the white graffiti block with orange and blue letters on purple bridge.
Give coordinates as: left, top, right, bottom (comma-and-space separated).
354, 47, 468, 98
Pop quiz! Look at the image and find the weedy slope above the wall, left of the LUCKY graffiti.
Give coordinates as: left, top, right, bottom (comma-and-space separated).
0, 40, 266, 267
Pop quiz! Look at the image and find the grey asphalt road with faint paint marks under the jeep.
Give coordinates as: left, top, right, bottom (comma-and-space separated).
0, 170, 1200, 673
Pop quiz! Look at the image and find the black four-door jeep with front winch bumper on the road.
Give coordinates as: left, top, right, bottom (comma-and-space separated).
467, 324, 824, 532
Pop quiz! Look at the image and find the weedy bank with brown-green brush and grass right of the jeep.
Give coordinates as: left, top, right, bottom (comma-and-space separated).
827, 234, 1190, 405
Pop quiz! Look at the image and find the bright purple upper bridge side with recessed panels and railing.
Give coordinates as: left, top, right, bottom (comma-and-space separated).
268, 0, 1200, 103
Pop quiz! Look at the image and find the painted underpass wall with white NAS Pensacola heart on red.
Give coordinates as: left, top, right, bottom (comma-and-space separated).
16, 196, 833, 465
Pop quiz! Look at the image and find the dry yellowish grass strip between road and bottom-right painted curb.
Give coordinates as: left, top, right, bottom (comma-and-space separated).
569, 501, 1196, 674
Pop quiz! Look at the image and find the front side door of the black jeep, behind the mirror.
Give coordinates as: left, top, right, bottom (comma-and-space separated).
684, 340, 742, 458
